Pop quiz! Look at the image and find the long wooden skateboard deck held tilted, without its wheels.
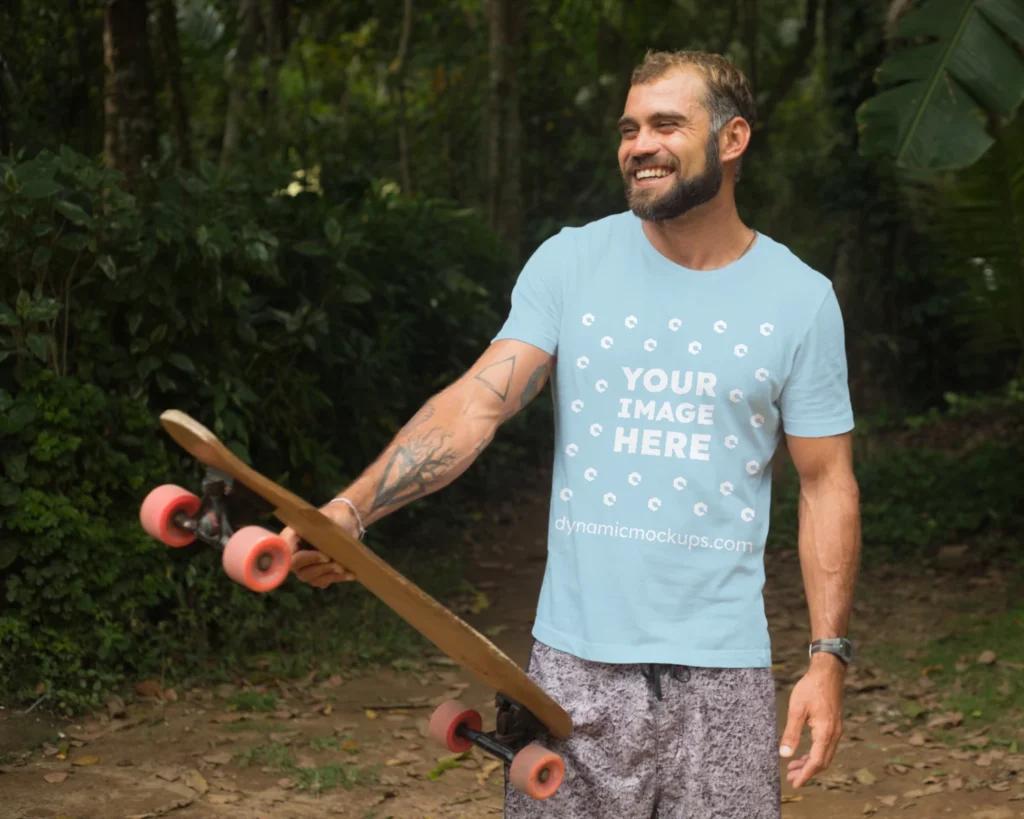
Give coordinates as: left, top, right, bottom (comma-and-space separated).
154, 410, 572, 739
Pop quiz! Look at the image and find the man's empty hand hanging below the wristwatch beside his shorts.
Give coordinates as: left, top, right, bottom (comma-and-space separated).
779, 653, 846, 788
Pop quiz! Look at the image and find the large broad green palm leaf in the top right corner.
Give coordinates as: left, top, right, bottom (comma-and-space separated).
857, 0, 1024, 170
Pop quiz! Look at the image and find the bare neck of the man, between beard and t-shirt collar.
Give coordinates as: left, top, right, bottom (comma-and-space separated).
643, 197, 754, 270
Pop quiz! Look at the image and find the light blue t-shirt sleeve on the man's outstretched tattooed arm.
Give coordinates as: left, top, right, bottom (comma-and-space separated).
493, 230, 575, 355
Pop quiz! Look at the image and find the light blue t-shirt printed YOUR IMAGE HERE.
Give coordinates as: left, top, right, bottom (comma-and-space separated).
495, 212, 853, 667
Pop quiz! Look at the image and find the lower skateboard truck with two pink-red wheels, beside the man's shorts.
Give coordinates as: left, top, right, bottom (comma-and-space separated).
430, 694, 565, 800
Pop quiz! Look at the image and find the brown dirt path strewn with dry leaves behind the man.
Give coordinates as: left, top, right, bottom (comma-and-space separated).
0, 479, 1024, 819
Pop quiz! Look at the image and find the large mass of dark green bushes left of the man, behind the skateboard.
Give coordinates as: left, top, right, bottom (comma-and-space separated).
0, 149, 524, 709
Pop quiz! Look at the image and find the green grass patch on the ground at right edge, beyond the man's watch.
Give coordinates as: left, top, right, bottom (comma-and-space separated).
867, 606, 1024, 745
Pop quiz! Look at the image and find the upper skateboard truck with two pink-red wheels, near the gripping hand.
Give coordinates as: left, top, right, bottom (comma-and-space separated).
139, 467, 292, 592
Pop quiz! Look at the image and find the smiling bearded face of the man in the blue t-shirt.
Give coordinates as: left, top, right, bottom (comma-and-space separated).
618, 70, 723, 222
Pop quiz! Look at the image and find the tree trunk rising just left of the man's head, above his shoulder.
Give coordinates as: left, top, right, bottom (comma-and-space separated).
486, 0, 525, 263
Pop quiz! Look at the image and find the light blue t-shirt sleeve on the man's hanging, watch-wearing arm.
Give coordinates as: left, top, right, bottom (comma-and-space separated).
779, 287, 853, 438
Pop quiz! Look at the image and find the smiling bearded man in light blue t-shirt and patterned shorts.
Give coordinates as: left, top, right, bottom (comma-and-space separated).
287, 52, 860, 819
